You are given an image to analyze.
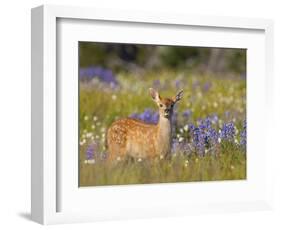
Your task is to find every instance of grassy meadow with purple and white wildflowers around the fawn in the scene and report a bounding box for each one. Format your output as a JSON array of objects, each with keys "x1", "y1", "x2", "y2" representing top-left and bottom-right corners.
[{"x1": 79, "y1": 67, "x2": 246, "y2": 186}]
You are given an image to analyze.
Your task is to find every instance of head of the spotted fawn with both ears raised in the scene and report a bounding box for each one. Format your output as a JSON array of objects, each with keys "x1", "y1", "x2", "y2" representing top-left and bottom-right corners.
[{"x1": 149, "y1": 88, "x2": 183, "y2": 119}]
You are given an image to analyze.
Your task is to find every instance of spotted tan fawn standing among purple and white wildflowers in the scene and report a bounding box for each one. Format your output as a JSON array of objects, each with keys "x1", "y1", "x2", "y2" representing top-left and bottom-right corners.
[{"x1": 106, "y1": 88, "x2": 183, "y2": 160}]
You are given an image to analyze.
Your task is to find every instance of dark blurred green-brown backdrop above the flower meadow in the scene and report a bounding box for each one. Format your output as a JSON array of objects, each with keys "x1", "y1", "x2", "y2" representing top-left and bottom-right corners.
[{"x1": 79, "y1": 42, "x2": 246, "y2": 76}]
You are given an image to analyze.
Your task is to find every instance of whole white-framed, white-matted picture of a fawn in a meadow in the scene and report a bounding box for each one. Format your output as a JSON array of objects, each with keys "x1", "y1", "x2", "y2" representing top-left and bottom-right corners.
[{"x1": 31, "y1": 6, "x2": 273, "y2": 224}]
